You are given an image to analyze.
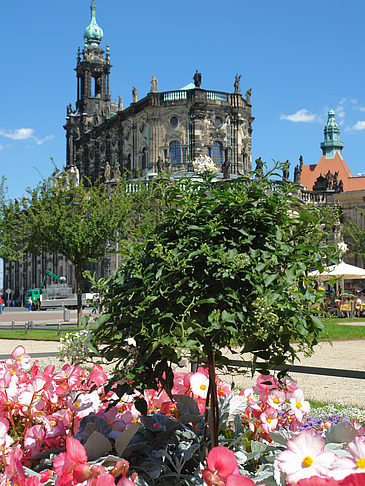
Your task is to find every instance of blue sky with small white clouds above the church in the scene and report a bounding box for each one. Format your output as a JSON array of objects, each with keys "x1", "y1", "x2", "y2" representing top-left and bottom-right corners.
[{"x1": 0, "y1": 0, "x2": 365, "y2": 197}]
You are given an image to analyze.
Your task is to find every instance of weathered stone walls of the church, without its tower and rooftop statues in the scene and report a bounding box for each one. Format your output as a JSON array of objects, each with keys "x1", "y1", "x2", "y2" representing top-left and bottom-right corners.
[{"x1": 65, "y1": 87, "x2": 253, "y2": 181}]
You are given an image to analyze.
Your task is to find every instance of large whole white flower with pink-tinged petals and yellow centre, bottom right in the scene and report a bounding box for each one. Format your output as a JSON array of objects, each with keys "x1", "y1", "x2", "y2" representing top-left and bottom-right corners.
[{"x1": 277, "y1": 430, "x2": 337, "y2": 484}]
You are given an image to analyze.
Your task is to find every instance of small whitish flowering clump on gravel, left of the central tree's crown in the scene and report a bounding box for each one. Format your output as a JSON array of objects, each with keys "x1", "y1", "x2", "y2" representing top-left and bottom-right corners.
[{"x1": 57, "y1": 329, "x2": 92, "y2": 363}]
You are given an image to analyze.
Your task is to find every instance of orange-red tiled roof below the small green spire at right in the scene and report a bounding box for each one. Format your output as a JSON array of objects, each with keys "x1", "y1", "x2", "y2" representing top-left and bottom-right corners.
[{"x1": 300, "y1": 153, "x2": 365, "y2": 192}]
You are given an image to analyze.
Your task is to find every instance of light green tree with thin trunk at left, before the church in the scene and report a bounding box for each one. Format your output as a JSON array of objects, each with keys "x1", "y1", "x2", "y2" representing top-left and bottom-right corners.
[{"x1": 0, "y1": 172, "x2": 162, "y2": 325}]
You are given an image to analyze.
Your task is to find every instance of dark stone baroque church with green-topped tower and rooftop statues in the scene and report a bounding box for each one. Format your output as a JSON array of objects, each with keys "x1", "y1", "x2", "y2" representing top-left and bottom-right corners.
[{"x1": 64, "y1": 0, "x2": 254, "y2": 181}]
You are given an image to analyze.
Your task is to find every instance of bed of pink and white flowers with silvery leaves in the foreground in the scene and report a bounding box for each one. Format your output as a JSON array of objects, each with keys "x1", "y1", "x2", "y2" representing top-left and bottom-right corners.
[{"x1": 0, "y1": 346, "x2": 365, "y2": 486}]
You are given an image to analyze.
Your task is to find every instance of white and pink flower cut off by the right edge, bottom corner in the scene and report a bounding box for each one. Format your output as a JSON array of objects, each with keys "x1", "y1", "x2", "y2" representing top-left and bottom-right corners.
[{"x1": 329, "y1": 436, "x2": 365, "y2": 480}]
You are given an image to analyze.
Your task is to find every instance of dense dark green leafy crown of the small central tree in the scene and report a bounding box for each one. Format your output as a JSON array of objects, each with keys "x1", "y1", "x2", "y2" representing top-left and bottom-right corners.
[{"x1": 91, "y1": 173, "x2": 336, "y2": 400}]
